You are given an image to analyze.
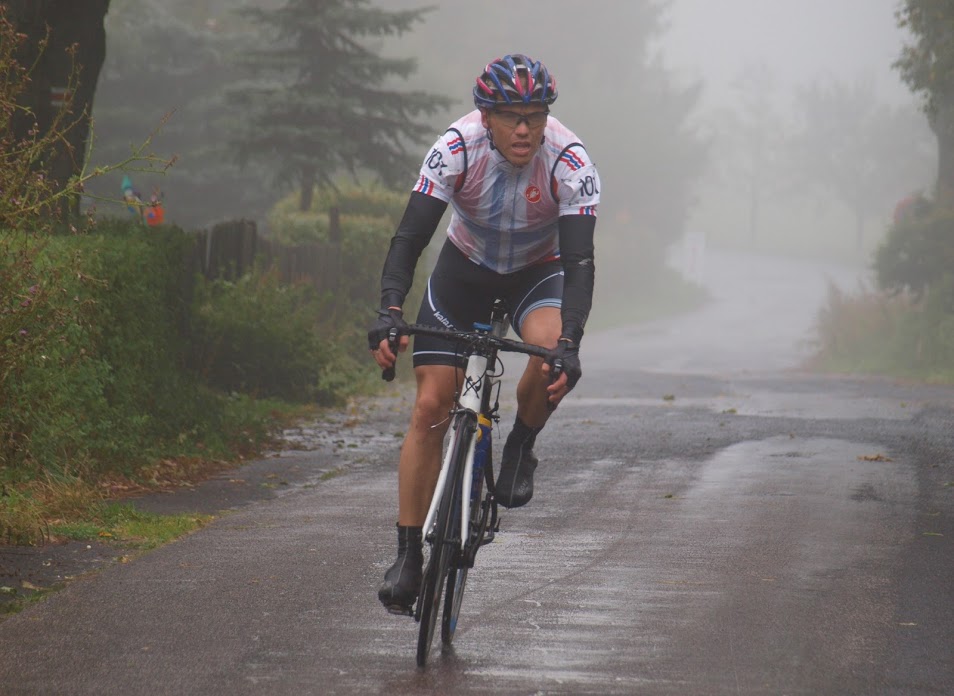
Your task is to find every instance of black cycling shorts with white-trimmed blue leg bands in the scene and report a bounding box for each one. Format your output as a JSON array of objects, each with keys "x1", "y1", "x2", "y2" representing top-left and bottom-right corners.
[{"x1": 414, "y1": 240, "x2": 563, "y2": 367}]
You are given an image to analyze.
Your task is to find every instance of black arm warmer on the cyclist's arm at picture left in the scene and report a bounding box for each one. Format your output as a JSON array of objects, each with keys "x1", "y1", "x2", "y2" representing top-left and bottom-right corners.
[{"x1": 381, "y1": 191, "x2": 447, "y2": 309}]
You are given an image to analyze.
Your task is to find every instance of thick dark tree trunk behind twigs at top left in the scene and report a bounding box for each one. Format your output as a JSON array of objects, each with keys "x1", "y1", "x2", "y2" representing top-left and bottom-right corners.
[{"x1": 7, "y1": 0, "x2": 110, "y2": 214}]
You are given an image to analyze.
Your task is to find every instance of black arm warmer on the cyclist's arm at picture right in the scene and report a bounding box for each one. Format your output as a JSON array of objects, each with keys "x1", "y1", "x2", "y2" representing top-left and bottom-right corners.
[{"x1": 559, "y1": 215, "x2": 596, "y2": 345}]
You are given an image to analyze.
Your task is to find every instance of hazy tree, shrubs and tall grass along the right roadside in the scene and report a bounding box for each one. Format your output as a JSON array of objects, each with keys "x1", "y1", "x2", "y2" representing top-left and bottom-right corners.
[{"x1": 814, "y1": 0, "x2": 954, "y2": 384}]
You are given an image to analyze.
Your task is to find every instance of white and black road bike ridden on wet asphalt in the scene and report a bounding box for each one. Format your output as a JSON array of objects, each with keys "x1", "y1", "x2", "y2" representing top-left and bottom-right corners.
[{"x1": 382, "y1": 300, "x2": 563, "y2": 667}]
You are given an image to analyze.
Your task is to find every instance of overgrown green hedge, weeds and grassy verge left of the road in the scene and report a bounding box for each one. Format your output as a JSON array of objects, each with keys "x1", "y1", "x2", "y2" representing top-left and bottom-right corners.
[{"x1": 0, "y1": 6, "x2": 376, "y2": 548}]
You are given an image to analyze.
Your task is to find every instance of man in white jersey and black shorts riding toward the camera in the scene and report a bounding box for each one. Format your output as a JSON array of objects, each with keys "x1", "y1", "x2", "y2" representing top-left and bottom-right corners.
[{"x1": 368, "y1": 54, "x2": 600, "y2": 613}]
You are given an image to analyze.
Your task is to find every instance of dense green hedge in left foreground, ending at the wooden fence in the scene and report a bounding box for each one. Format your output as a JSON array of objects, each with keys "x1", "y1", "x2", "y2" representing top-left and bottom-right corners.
[{"x1": 0, "y1": 223, "x2": 274, "y2": 479}]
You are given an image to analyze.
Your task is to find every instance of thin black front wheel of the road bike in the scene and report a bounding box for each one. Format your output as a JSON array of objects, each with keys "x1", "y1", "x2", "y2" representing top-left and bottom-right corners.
[{"x1": 417, "y1": 414, "x2": 473, "y2": 667}]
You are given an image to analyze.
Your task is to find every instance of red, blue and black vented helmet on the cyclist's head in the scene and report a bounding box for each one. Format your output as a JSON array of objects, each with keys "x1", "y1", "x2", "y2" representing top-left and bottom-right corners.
[{"x1": 474, "y1": 53, "x2": 557, "y2": 109}]
